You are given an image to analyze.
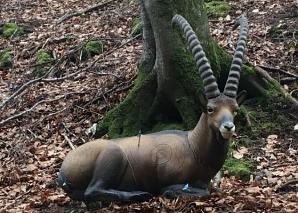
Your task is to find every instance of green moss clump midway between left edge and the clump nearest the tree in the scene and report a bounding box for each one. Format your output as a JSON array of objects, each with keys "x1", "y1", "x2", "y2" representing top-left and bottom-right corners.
[{"x1": 33, "y1": 49, "x2": 54, "y2": 77}]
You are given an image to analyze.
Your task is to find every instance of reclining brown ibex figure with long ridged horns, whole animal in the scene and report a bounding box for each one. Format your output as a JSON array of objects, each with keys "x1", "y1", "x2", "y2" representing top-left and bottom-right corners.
[{"x1": 58, "y1": 15, "x2": 248, "y2": 207}]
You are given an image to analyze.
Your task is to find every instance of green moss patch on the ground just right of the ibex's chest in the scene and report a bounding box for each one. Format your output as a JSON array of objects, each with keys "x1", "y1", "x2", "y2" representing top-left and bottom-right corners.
[{"x1": 223, "y1": 157, "x2": 253, "y2": 180}]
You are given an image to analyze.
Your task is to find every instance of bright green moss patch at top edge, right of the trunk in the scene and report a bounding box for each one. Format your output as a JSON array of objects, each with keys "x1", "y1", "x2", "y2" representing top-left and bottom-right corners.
[{"x1": 205, "y1": 1, "x2": 231, "y2": 17}]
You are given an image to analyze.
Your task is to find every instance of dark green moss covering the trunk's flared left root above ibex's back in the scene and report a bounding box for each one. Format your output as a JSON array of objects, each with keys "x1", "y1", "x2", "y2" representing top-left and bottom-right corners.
[{"x1": 96, "y1": 71, "x2": 156, "y2": 138}]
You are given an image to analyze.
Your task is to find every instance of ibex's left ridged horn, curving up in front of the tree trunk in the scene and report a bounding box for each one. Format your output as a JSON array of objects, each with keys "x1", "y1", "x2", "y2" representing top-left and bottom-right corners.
[{"x1": 172, "y1": 14, "x2": 220, "y2": 99}]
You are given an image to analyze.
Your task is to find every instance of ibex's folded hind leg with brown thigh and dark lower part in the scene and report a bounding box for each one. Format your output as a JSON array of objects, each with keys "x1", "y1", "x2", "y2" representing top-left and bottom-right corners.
[{"x1": 84, "y1": 144, "x2": 152, "y2": 201}]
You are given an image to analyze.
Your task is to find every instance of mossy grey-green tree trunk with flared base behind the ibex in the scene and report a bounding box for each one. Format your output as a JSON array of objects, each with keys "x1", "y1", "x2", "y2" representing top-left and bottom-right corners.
[{"x1": 97, "y1": 0, "x2": 265, "y2": 137}]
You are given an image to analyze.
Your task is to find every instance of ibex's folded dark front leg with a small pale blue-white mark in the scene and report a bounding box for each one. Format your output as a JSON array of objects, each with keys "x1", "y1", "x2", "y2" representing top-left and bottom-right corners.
[{"x1": 161, "y1": 184, "x2": 210, "y2": 198}]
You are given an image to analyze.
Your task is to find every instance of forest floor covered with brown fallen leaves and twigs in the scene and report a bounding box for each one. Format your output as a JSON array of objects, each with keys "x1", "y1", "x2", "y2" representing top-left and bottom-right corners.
[{"x1": 0, "y1": 0, "x2": 298, "y2": 212}]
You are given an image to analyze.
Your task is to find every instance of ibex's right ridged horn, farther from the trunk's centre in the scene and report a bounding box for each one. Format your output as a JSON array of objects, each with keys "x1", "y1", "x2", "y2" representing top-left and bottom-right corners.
[{"x1": 223, "y1": 15, "x2": 248, "y2": 98}]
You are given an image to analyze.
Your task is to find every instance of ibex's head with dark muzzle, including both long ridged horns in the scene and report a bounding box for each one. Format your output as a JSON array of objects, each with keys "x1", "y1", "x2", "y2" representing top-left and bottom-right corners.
[{"x1": 172, "y1": 15, "x2": 248, "y2": 140}]
